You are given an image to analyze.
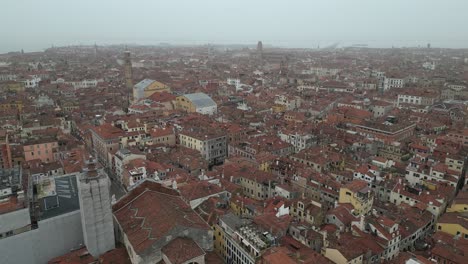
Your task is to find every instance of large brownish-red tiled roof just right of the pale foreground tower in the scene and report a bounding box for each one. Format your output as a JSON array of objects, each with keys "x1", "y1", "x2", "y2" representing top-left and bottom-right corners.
[{"x1": 112, "y1": 181, "x2": 210, "y2": 253}]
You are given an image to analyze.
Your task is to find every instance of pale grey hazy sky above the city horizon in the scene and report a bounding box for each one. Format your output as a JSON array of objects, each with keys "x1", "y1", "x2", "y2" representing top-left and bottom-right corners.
[{"x1": 0, "y1": 0, "x2": 468, "y2": 52}]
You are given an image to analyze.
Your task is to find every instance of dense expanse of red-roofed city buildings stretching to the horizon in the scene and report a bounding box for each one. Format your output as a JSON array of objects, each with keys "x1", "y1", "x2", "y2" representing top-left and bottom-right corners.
[{"x1": 0, "y1": 44, "x2": 468, "y2": 264}]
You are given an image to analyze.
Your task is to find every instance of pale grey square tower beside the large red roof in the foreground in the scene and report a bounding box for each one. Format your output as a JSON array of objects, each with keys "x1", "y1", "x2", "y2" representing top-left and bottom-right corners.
[{"x1": 78, "y1": 159, "x2": 115, "y2": 257}]
